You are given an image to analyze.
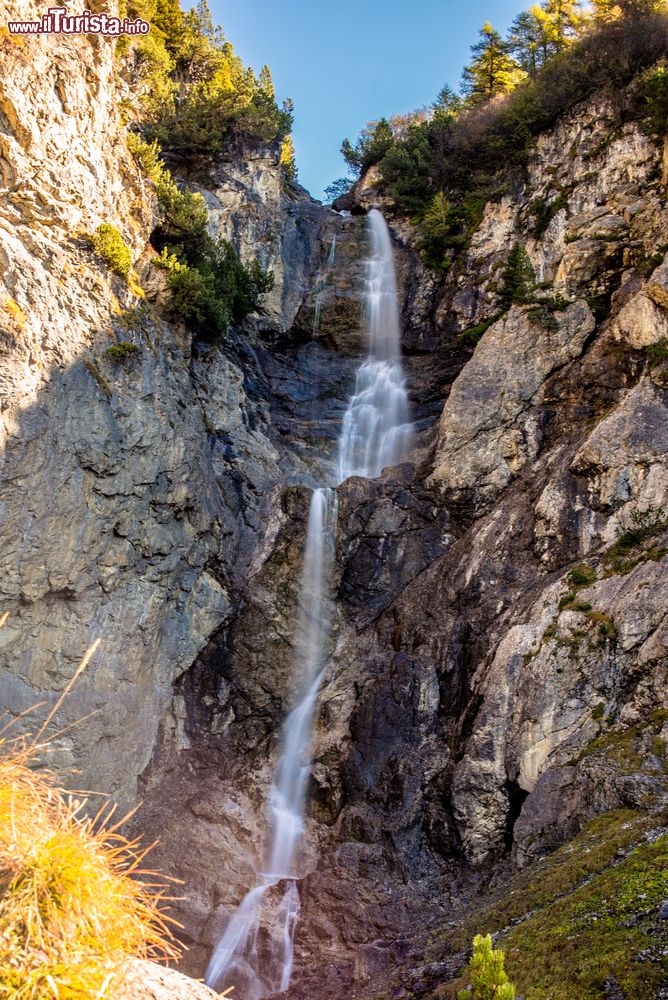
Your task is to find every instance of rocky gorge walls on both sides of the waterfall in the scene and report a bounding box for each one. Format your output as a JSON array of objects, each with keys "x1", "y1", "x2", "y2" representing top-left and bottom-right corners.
[{"x1": 0, "y1": 15, "x2": 668, "y2": 1000}]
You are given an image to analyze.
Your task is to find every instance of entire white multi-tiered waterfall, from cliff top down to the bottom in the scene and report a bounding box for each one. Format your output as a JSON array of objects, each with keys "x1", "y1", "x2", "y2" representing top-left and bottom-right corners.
[{"x1": 206, "y1": 210, "x2": 411, "y2": 1000}]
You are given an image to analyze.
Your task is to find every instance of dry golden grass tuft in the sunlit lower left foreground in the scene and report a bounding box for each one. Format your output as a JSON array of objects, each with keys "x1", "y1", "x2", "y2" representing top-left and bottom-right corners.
[{"x1": 0, "y1": 632, "x2": 183, "y2": 1000}]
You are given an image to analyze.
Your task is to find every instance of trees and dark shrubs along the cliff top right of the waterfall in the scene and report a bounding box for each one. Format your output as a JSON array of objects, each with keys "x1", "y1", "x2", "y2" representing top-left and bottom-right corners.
[{"x1": 342, "y1": 0, "x2": 668, "y2": 268}]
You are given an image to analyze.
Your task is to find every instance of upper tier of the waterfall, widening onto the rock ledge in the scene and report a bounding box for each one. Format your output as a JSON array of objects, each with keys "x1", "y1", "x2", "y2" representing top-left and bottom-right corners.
[{"x1": 339, "y1": 209, "x2": 411, "y2": 482}]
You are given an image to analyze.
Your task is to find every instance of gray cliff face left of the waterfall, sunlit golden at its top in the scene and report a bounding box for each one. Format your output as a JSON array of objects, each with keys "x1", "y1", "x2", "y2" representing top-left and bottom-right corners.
[{"x1": 0, "y1": 15, "x2": 359, "y2": 807}]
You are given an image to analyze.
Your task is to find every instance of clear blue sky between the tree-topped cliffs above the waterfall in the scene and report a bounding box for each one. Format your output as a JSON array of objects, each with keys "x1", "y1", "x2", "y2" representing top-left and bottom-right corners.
[{"x1": 206, "y1": 0, "x2": 531, "y2": 197}]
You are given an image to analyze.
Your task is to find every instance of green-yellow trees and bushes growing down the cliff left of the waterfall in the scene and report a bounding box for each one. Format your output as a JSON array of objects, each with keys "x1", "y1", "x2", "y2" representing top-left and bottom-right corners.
[{"x1": 115, "y1": 0, "x2": 280, "y2": 343}]
